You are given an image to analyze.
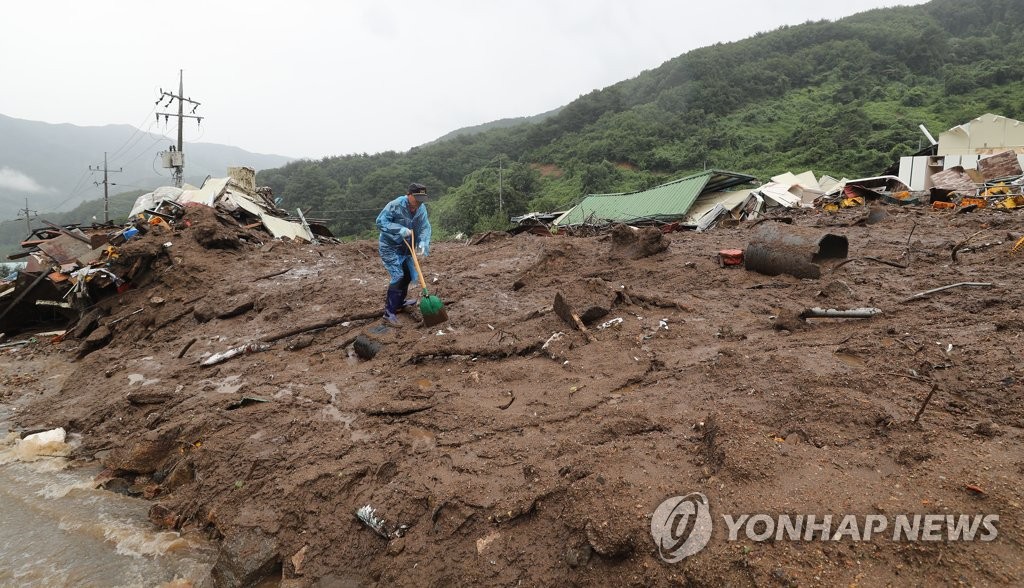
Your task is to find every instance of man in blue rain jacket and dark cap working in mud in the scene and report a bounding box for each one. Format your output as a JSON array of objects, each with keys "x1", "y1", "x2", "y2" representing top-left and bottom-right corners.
[{"x1": 377, "y1": 182, "x2": 430, "y2": 325}]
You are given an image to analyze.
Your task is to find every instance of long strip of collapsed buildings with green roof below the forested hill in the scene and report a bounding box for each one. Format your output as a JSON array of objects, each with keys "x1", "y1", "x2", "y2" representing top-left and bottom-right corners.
[{"x1": 511, "y1": 114, "x2": 1024, "y2": 235}]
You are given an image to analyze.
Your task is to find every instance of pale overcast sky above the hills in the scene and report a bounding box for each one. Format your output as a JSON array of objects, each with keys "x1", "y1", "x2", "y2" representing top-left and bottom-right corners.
[{"x1": 0, "y1": 0, "x2": 923, "y2": 158}]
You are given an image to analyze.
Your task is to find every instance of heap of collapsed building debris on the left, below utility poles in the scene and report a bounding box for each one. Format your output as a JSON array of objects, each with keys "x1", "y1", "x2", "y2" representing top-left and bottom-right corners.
[{"x1": 0, "y1": 167, "x2": 335, "y2": 335}]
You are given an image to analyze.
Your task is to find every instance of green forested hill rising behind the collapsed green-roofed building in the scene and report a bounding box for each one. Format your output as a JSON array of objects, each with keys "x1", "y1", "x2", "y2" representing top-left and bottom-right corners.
[{"x1": 253, "y1": 0, "x2": 1024, "y2": 239}]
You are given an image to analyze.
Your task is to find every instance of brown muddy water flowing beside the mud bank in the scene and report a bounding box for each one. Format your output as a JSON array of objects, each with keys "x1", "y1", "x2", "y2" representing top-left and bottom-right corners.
[{"x1": 0, "y1": 407, "x2": 216, "y2": 587}]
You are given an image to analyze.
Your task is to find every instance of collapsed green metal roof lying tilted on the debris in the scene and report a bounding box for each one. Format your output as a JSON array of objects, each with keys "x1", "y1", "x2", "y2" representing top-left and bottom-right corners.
[{"x1": 555, "y1": 170, "x2": 756, "y2": 226}]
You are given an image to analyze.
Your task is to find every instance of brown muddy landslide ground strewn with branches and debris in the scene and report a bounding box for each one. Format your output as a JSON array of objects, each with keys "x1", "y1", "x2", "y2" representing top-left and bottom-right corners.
[{"x1": 2, "y1": 207, "x2": 1024, "y2": 586}]
